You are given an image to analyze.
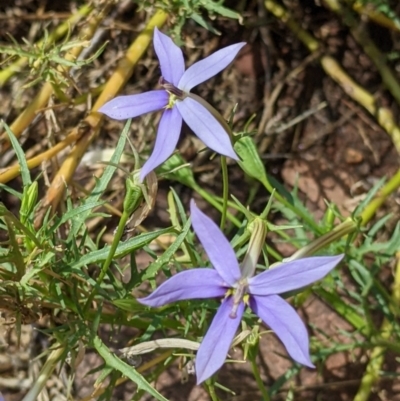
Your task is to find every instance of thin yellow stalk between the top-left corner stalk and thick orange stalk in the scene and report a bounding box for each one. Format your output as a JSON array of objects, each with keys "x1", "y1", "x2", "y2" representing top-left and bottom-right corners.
[{"x1": 0, "y1": 1, "x2": 113, "y2": 147}]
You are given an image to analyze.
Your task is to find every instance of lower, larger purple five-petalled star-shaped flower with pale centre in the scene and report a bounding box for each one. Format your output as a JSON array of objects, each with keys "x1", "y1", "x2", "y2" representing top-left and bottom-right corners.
[{"x1": 138, "y1": 201, "x2": 343, "y2": 384}]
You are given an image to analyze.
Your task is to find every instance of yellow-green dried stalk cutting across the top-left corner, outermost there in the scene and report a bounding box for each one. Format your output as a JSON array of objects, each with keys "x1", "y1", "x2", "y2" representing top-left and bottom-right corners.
[{"x1": 0, "y1": 4, "x2": 93, "y2": 88}]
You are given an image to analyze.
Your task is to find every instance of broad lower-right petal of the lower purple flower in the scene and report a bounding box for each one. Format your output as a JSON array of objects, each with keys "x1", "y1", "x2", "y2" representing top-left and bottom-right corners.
[{"x1": 250, "y1": 295, "x2": 315, "y2": 368}]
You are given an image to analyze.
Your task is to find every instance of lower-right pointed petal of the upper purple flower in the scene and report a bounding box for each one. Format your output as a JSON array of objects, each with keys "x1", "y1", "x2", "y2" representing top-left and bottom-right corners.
[{"x1": 176, "y1": 97, "x2": 238, "y2": 160}]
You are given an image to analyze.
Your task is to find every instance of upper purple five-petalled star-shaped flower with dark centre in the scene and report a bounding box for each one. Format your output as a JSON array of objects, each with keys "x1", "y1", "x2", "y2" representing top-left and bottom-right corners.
[{"x1": 99, "y1": 28, "x2": 245, "y2": 181}]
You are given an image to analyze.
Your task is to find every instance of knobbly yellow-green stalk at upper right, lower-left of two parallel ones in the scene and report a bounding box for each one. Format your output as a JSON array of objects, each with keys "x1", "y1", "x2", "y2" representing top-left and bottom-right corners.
[{"x1": 264, "y1": 0, "x2": 400, "y2": 154}]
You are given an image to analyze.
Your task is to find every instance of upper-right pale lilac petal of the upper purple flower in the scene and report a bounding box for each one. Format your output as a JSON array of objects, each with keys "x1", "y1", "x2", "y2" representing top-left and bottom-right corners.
[{"x1": 178, "y1": 42, "x2": 246, "y2": 92}]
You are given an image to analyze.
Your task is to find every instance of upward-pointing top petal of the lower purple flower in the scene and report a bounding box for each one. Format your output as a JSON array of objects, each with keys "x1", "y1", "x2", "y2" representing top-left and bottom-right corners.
[{"x1": 190, "y1": 199, "x2": 240, "y2": 286}]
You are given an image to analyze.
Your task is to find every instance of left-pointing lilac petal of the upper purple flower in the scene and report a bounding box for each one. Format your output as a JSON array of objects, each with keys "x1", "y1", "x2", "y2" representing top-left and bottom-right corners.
[{"x1": 98, "y1": 89, "x2": 169, "y2": 120}]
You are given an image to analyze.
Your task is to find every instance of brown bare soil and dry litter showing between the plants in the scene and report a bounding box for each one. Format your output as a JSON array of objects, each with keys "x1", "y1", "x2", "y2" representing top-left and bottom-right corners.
[{"x1": 0, "y1": 0, "x2": 400, "y2": 401}]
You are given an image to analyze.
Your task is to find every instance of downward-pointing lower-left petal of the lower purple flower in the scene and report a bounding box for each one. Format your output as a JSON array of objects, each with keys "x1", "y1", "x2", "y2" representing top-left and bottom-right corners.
[{"x1": 196, "y1": 297, "x2": 244, "y2": 384}]
